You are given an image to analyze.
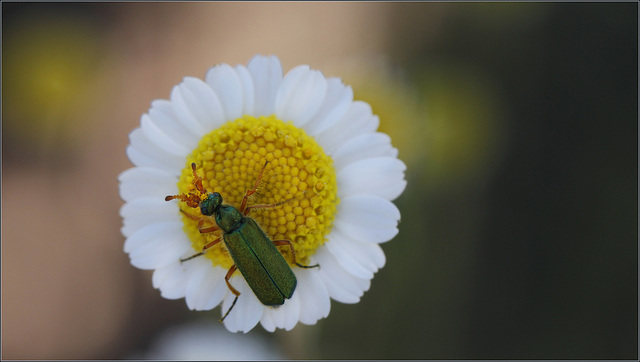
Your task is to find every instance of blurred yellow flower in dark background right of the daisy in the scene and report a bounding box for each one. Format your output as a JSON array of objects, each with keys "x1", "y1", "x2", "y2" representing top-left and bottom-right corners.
[{"x1": 419, "y1": 64, "x2": 505, "y2": 184}]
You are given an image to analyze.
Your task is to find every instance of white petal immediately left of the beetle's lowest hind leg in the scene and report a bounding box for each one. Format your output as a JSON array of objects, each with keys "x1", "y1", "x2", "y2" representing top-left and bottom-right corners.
[{"x1": 184, "y1": 257, "x2": 228, "y2": 310}]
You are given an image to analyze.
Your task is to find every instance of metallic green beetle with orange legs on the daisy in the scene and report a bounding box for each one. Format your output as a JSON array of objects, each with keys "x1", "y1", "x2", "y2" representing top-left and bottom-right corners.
[{"x1": 165, "y1": 161, "x2": 319, "y2": 322}]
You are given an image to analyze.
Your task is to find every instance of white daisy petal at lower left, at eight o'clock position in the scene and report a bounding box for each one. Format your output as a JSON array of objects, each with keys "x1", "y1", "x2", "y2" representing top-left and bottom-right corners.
[{"x1": 124, "y1": 221, "x2": 191, "y2": 269}]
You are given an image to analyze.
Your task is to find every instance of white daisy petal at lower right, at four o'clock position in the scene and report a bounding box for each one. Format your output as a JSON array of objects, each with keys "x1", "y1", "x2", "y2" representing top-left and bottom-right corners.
[{"x1": 325, "y1": 229, "x2": 384, "y2": 279}]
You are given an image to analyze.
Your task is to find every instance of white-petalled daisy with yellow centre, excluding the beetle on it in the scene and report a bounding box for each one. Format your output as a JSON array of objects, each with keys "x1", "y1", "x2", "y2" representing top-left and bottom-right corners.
[{"x1": 119, "y1": 56, "x2": 406, "y2": 333}]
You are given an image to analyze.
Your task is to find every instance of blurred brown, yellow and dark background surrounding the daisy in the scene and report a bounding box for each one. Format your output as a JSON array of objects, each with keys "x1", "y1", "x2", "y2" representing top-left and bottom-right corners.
[{"x1": 2, "y1": 2, "x2": 638, "y2": 359}]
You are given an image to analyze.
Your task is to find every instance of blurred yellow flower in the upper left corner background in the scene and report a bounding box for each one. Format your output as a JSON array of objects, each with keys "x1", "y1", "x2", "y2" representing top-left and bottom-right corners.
[{"x1": 2, "y1": 13, "x2": 101, "y2": 155}]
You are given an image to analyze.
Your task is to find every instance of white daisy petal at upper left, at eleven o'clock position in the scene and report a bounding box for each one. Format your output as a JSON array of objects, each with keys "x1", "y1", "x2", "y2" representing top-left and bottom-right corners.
[{"x1": 171, "y1": 77, "x2": 225, "y2": 136}]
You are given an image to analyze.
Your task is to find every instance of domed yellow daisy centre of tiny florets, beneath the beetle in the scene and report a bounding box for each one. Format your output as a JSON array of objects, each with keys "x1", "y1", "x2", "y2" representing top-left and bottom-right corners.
[{"x1": 172, "y1": 116, "x2": 339, "y2": 268}]
